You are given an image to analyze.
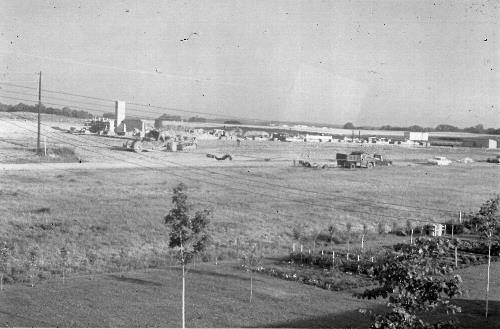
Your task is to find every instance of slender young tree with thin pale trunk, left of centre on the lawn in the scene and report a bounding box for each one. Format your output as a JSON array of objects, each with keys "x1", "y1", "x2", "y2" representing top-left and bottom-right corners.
[{"x1": 164, "y1": 183, "x2": 211, "y2": 328}]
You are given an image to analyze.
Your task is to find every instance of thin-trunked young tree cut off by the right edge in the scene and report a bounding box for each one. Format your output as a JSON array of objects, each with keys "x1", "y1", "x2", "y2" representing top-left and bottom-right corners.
[{"x1": 472, "y1": 196, "x2": 500, "y2": 317}]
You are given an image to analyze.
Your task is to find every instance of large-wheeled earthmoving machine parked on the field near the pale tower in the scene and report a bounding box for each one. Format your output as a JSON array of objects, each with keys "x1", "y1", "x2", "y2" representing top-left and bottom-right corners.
[{"x1": 123, "y1": 129, "x2": 198, "y2": 153}]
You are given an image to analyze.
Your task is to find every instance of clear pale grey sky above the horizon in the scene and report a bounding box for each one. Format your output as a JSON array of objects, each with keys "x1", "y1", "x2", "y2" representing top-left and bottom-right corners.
[{"x1": 0, "y1": 0, "x2": 500, "y2": 128}]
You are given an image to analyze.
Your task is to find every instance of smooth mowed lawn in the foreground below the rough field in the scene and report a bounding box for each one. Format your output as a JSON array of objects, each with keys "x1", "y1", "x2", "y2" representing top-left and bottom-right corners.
[{"x1": 0, "y1": 263, "x2": 500, "y2": 328}]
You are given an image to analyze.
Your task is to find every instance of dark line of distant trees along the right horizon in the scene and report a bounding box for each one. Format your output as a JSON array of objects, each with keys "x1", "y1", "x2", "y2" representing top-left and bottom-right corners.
[{"x1": 343, "y1": 122, "x2": 500, "y2": 135}]
